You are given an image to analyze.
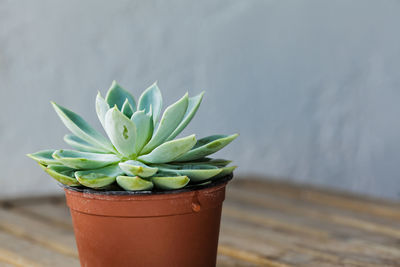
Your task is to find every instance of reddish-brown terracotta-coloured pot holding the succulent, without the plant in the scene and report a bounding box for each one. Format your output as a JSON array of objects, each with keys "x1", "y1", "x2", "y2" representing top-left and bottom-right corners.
[{"x1": 64, "y1": 176, "x2": 232, "y2": 267}]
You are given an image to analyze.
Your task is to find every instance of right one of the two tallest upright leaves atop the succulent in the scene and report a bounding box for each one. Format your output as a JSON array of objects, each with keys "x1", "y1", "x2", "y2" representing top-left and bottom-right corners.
[{"x1": 138, "y1": 82, "x2": 162, "y2": 125}]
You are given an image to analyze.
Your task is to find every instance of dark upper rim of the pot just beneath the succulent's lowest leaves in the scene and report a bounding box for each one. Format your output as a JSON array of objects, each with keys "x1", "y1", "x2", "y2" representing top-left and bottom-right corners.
[{"x1": 58, "y1": 173, "x2": 233, "y2": 196}]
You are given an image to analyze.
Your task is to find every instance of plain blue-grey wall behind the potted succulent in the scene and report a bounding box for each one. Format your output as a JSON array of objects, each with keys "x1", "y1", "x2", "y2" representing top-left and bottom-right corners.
[{"x1": 0, "y1": 0, "x2": 400, "y2": 198}]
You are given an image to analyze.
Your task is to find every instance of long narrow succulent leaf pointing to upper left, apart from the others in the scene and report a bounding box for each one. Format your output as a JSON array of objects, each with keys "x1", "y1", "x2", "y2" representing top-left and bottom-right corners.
[{"x1": 51, "y1": 102, "x2": 114, "y2": 152}]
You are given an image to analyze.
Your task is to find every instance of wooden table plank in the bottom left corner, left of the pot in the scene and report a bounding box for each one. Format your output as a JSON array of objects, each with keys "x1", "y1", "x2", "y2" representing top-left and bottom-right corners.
[{"x1": 0, "y1": 231, "x2": 79, "y2": 267}]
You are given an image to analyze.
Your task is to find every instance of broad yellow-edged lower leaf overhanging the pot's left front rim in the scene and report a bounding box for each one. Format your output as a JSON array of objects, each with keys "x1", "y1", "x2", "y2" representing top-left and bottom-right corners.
[{"x1": 75, "y1": 165, "x2": 123, "y2": 188}]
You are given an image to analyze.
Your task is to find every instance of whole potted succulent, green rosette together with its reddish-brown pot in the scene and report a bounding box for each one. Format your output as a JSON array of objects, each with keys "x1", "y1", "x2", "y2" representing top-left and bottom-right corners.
[{"x1": 28, "y1": 81, "x2": 238, "y2": 267}]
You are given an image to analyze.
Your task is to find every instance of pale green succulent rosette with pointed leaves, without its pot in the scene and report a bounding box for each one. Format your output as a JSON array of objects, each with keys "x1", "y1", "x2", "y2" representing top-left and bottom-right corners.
[{"x1": 28, "y1": 81, "x2": 238, "y2": 191}]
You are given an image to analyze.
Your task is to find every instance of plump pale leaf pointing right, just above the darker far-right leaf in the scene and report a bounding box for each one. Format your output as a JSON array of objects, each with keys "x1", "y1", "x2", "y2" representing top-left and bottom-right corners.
[{"x1": 138, "y1": 134, "x2": 196, "y2": 163}]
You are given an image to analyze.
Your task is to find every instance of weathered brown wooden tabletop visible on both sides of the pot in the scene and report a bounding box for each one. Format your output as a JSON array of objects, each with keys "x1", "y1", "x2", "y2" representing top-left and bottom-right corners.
[{"x1": 0, "y1": 179, "x2": 400, "y2": 267}]
